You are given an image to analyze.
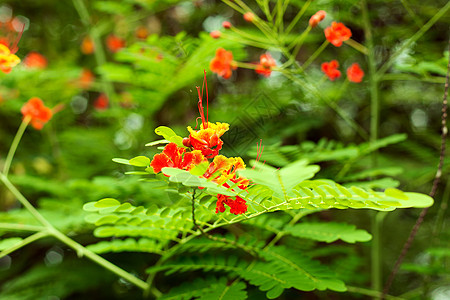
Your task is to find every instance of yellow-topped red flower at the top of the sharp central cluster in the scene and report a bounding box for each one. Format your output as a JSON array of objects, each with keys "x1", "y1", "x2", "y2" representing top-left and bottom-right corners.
[{"x1": 185, "y1": 122, "x2": 230, "y2": 158}]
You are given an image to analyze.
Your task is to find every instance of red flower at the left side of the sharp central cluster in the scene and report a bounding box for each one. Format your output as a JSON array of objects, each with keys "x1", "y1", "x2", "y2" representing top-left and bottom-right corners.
[{"x1": 150, "y1": 143, "x2": 205, "y2": 173}]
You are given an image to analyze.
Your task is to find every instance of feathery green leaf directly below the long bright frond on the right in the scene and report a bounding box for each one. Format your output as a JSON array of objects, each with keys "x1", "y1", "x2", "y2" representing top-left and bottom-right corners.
[{"x1": 284, "y1": 222, "x2": 372, "y2": 243}]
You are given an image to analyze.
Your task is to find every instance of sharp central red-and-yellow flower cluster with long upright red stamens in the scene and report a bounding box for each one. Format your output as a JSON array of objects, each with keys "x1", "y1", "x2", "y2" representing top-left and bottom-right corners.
[{"x1": 150, "y1": 75, "x2": 249, "y2": 215}]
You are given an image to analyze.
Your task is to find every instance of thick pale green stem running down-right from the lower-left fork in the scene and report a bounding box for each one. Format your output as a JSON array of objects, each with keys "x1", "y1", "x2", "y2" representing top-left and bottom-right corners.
[{"x1": 50, "y1": 228, "x2": 148, "y2": 290}]
